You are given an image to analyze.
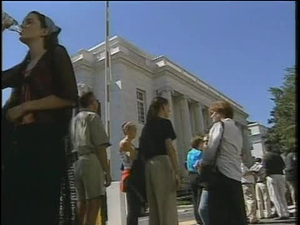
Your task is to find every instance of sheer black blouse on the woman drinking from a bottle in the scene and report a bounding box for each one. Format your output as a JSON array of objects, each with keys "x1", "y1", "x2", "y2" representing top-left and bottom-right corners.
[{"x1": 1, "y1": 45, "x2": 78, "y2": 131}]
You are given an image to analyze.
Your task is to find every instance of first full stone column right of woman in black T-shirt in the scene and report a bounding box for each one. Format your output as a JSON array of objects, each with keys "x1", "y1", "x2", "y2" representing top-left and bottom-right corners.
[{"x1": 179, "y1": 96, "x2": 192, "y2": 157}]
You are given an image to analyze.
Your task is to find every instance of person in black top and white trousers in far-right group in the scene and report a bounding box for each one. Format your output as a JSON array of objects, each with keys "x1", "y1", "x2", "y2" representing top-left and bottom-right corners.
[{"x1": 263, "y1": 149, "x2": 289, "y2": 220}]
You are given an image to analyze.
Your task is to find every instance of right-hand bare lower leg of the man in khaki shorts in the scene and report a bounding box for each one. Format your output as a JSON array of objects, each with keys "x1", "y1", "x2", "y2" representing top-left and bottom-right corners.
[{"x1": 83, "y1": 197, "x2": 100, "y2": 225}]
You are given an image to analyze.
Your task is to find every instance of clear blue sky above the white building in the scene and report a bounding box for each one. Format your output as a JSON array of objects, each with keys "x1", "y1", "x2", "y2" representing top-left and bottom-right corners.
[{"x1": 2, "y1": 1, "x2": 295, "y2": 125}]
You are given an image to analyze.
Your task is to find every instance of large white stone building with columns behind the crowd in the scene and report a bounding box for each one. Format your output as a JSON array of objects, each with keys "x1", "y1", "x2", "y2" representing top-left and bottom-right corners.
[{"x1": 72, "y1": 36, "x2": 250, "y2": 180}]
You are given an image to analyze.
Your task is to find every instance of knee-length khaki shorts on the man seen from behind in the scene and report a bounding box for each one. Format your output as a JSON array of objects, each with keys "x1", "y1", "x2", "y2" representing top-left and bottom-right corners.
[{"x1": 74, "y1": 153, "x2": 105, "y2": 201}]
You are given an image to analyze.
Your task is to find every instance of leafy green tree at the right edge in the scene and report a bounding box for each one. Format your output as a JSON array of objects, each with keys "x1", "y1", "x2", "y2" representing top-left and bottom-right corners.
[{"x1": 265, "y1": 67, "x2": 296, "y2": 152}]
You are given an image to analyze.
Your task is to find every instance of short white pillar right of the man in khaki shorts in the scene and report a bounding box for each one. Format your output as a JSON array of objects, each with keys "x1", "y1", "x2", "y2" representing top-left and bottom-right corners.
[{"x1": 106, "y1": 181, "x2": 127, "y2": 225}]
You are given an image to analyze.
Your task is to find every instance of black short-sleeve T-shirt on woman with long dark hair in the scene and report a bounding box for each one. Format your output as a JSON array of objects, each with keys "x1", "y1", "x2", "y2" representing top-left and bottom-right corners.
[{"x1": 140, "y1": 117, "x2": 176, "y2": 159}]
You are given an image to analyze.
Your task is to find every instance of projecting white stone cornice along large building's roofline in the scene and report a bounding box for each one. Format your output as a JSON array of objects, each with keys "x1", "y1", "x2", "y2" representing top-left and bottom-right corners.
[{"x1": 71, "y1": 36, "x2": 248, "y2": 117}]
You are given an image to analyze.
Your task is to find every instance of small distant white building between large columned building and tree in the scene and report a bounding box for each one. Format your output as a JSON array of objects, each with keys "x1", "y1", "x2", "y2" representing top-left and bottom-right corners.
[{"x1": 248, "y1": 122, "x2": 268, "y2": 158}]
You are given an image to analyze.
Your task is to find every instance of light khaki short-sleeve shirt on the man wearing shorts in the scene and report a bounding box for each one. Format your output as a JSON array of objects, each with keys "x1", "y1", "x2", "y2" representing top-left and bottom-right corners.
[{"x1": 70, "y1": 110, "x2": 110, "y2": 155}]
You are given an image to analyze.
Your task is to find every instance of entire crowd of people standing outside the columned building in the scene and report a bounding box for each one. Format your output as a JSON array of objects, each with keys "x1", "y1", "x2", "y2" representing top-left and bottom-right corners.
[{"x1": 2, "y1": 11, "x2": 297, "y2": 225}]
